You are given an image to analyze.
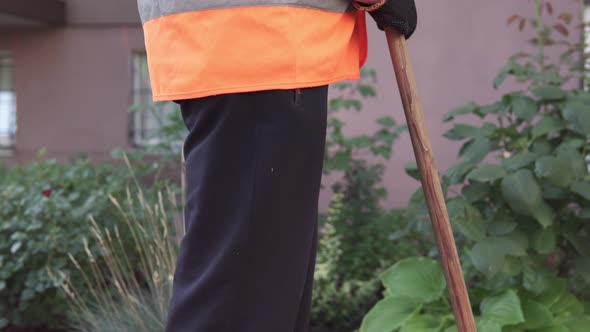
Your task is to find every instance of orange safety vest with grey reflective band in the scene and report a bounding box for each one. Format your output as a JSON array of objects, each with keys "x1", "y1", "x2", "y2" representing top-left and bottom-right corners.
[{"x1": 138, "y1": 0, "x2": 367, "y2": 101}]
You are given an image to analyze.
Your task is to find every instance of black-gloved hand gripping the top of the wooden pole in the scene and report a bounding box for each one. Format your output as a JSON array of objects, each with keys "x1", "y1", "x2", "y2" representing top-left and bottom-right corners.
[{"x1": 357, "y1": 0, "x2": 418, "y2": 38}]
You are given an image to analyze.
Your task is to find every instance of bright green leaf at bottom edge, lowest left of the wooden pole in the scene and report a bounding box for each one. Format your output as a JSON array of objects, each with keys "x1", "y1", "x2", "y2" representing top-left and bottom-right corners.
[{"x1": 361, "y1": 297, "x2": 421, "y2": 332}]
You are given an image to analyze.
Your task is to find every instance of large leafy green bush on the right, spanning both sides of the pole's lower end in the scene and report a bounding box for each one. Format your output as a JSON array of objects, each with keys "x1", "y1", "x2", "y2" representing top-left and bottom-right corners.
[{"x1": 361, "y1": 0, "x2": 590, "y2": 332}]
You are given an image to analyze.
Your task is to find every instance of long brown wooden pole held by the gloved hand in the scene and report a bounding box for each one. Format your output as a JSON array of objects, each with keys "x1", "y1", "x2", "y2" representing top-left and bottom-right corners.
[{"x1": 385, "y1": 28, "x2": 477, "y2": 332}]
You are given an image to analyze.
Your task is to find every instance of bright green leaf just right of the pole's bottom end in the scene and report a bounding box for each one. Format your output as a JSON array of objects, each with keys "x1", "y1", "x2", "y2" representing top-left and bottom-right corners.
[{"x1": 480, "y1": 290, "x2": 524, "y2": 326}]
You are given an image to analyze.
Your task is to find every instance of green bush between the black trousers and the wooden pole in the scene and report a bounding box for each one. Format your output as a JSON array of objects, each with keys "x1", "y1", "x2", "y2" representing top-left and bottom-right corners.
[{"x1": 312, "y1": 70, "x2": 430, "y2": 332}]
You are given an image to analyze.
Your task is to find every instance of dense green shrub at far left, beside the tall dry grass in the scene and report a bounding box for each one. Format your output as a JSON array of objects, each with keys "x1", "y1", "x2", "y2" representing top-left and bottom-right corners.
[{"x1": 0, "y1": 154, "x2": 176, "y2": 328}]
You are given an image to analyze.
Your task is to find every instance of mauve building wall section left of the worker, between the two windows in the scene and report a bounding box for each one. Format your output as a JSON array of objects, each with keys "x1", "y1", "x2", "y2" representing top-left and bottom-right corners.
[{"x1": 0, "y1": 0, "x2": 144, "y2": 162}]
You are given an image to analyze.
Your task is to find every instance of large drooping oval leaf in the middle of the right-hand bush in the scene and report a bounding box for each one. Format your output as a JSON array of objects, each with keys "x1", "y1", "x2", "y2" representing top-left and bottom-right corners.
[{"x1": 502, "y1": 169, "x2": 553, "y2": 227}]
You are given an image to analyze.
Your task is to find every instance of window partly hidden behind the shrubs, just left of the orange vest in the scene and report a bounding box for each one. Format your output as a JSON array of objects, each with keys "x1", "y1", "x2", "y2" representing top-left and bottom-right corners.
[{"x1": 129, "y1": 53, "x2": 178, "y2": 147}]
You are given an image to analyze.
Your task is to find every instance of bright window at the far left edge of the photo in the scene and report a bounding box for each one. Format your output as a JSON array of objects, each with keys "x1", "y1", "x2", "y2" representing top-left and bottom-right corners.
[{"x1": 0, "y1": 51, "x2": 16, "y2": 153}]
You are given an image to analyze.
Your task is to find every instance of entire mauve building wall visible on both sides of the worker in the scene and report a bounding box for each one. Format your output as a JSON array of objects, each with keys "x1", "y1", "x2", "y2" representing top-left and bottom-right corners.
[{"x1": 0, "y1": 0, "x2": 577, "y2": 206}]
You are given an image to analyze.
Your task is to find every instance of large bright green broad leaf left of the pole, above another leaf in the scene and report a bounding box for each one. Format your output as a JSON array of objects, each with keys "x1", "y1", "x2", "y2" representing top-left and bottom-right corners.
[{"x1": 380, "y1": 257, "x2": 445, "y2": 302}]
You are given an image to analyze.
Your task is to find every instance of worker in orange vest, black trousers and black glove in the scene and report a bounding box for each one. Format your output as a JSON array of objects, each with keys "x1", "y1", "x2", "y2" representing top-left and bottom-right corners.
[{"x1": 138, "y1": 0, "x2": 417, "y2": 332}]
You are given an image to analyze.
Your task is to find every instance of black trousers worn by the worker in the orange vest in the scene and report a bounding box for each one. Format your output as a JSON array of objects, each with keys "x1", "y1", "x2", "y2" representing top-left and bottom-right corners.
[{"x1": 166, "y1": 86, "x2": 327, "y2": 332}]
